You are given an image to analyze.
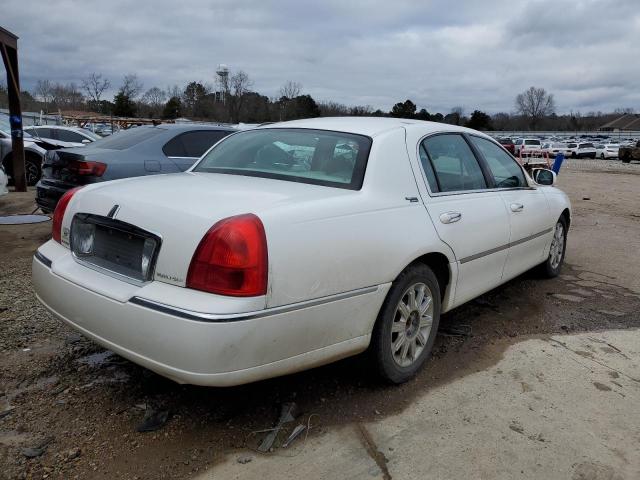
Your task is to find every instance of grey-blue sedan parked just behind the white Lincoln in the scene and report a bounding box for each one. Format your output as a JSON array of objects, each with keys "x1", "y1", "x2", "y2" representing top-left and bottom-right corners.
[{"x1": 36, "y1": 124, "x2": 236, "y2": 213}]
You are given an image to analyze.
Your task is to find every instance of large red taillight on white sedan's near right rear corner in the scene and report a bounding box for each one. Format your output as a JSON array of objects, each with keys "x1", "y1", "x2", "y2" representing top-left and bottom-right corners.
[{"x1": 186, "y1": 214, "x2": 268, "y2": 297}]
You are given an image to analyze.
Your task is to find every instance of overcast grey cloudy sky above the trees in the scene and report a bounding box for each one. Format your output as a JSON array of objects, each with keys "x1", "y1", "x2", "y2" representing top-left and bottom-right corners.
[{"x1": 0, "y1": 0, "x2": 640, "y2": 113}]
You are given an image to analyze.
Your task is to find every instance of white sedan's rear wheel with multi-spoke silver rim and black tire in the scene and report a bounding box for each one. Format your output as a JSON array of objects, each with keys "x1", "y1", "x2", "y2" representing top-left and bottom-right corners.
[{"x1": 370, "y1": 264, "x2": 441, "y2": 384}]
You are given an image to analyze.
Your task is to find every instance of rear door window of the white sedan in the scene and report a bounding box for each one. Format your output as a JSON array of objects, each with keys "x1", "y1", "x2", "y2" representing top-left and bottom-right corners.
[{"x1": 421, "y1": 134, "x2": 487, "y2": 192}]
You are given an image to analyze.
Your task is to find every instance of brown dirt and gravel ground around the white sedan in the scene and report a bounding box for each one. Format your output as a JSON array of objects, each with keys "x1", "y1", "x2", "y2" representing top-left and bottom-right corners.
[{"x1": 0, "y1": 161, "x2": 640, "y2": 479}]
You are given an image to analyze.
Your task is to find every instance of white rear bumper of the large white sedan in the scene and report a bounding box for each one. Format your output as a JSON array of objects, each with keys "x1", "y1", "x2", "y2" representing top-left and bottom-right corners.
[{"x1": 33, "y1": 242, "x2": 390, "y2": 386}]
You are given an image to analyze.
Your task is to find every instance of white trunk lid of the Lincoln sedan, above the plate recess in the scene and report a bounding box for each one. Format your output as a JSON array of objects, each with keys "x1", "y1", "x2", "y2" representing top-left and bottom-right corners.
[{"x1": 65, "y1": 172, "x2": 355, "y2": 286}]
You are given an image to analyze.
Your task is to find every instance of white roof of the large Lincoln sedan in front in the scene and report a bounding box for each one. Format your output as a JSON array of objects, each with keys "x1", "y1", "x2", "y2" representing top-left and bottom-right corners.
[{"x1": 258, "y1": 117, "x2": 475, "y2": 137}]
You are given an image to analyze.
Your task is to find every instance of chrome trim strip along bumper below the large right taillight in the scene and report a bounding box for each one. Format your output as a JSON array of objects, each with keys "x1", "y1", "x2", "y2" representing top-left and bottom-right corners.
[{"x1": 129, "y1": 286, "x2": 378, "y2": 322}]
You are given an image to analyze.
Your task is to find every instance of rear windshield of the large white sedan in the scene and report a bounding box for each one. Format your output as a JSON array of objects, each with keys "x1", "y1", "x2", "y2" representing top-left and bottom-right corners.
[{"x1": 193, "y1": 128, "x2": 371, "y2": 190}]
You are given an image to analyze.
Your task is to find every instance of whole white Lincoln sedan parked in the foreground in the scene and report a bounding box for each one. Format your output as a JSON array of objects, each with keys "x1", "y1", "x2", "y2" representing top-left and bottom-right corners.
[{"x1": 33, "y1": 117, "x2": 571, "y2": 386}]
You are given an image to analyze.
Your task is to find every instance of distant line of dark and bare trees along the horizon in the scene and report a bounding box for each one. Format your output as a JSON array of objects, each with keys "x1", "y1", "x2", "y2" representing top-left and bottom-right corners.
[{"x1": 0, "y1": 70, "x2": 633, "y2": 131}]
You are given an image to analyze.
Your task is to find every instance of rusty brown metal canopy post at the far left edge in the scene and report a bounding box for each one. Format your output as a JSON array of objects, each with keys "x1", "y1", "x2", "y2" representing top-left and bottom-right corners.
[{"x1": 0, "y1": 27, "x2": 27, "y2": 192}]
